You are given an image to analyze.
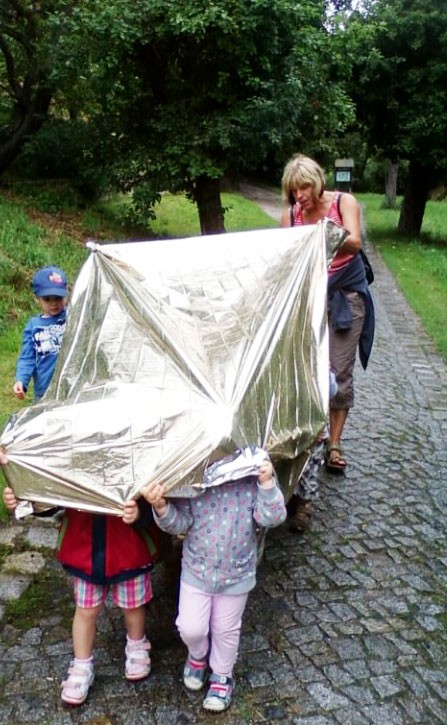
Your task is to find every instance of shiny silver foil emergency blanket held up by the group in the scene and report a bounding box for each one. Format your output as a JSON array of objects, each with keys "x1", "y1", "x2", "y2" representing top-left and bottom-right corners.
[{"x1": 0, "y1": 220, "x2": 346, "y2": 514}]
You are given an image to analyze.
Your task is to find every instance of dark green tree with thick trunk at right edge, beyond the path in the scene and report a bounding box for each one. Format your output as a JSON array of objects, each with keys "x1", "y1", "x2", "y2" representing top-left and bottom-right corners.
[{"x1": 350, "y1": 0, "x2": 447, "y2": 236}]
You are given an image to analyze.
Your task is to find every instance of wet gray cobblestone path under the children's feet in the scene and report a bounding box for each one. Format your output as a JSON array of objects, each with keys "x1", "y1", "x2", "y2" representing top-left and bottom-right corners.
[{"x1": 0, "y1": 194, "x2": 447, "y2": 725}]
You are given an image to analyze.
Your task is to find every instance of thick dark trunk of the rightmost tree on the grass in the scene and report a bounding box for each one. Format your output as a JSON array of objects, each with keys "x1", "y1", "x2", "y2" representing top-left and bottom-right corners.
[{"x1": 397, "y1": 161, "x2": 431, "y2": 237}]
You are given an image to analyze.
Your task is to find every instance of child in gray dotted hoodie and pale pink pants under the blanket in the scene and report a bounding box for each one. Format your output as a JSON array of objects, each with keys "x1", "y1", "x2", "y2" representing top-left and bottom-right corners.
[{"x1": 142, "y1": 448, "x2": 286, "y2": 712}]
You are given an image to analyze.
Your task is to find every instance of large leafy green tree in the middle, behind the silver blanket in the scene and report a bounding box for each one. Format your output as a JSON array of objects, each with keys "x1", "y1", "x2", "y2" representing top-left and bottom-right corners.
[{"x1": 63, "y1": 0, "x2": 352, "y2": 233}]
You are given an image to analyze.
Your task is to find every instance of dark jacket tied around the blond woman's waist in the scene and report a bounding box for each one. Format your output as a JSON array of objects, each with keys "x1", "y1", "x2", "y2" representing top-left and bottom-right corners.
[{"x1": 328, "y1": 254, "x2": 375, "y2": 370}]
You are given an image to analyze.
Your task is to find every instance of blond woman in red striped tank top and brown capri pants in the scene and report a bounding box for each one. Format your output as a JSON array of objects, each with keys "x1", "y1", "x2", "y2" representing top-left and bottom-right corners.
[{"x1": 281, "y1": 154, "x2": 374, "y2": 473}]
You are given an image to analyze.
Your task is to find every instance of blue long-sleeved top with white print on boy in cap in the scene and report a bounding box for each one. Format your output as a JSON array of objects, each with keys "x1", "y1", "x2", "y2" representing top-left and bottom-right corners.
[{"x1": 15, "y1": 310, "x2": 67, "y2": 398}]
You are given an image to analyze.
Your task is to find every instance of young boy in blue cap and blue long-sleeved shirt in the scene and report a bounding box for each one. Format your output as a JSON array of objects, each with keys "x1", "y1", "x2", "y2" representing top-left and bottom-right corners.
[{"x1": 12, "y1": 266, "x2": 68, "y2": 400}]
